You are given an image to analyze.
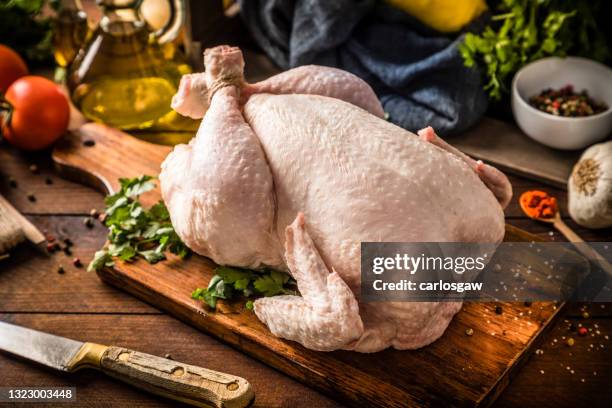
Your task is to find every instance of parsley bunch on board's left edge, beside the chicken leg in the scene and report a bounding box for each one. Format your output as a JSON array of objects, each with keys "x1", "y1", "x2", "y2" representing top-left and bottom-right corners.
[{"x1": 88, "y1": 176, "x2": 189, "y2": 270}]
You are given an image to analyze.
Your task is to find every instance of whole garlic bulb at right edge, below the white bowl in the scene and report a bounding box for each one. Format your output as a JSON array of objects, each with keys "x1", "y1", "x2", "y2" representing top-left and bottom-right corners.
[{"x1": 567, "y1": 141, "x2": 612, "y2": 228}]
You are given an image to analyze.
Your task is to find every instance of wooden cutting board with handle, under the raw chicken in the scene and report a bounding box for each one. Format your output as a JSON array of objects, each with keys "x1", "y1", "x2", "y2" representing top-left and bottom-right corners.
[{"x1": 53, "y1": 124, "x2": 560, "y2": 407}]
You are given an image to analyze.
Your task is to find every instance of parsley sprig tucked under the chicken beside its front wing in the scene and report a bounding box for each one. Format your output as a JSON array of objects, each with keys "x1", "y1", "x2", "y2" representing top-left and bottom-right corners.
[{"x1": 191, "y1": 266, "x2": 296, "y2": 310}]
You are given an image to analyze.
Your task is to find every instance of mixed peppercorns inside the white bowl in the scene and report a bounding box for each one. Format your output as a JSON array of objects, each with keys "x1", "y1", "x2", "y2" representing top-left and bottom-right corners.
[{"x1": 529, "y1": 85, "x2": 608, "y2": 117}]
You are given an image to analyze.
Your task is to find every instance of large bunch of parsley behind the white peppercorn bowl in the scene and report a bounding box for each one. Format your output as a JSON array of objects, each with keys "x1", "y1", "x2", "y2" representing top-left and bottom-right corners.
[{"x1": 459, "y1": 0, "x2": 610, "y2": 100}]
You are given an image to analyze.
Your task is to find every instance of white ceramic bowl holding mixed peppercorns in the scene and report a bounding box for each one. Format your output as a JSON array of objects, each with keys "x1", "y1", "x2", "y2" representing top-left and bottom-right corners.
[{"x1": 512, "y1": 57, "x2": 612, "y2": 150}]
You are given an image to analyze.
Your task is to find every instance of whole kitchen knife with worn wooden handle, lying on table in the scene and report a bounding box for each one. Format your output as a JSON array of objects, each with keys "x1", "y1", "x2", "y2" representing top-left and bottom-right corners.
[{"x1": 0, "y1": 321, "x2": 255, "y2": 408}]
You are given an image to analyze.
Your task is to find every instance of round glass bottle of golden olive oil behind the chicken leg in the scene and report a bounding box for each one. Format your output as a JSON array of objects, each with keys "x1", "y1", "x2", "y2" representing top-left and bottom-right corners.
[{"x1": 68, "y1": 0, "x2": 197, "y2": 132}]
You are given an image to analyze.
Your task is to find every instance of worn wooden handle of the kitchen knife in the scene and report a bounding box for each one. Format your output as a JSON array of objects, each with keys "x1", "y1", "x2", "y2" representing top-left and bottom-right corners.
[{"x1": 100, "y1": 347, "x2": 254, "y2": 408}]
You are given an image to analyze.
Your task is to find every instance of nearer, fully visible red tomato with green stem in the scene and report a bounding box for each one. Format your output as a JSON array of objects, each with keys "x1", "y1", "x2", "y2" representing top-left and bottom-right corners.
[{"x1": 3, "y1": 76, "x2": 70, "y2": 150}]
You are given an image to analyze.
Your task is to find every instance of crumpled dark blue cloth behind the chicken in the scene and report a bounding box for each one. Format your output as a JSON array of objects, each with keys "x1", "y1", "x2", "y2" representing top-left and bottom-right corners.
[{"x1": 241, "y1": 0, "x2": 487, "y2": 135}]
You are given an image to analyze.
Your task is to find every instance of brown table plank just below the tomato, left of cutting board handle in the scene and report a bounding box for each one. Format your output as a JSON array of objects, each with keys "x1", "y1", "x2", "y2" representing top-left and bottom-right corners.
[{"x1": 0, "y1": 145, "x2": 103, "y2": 214}]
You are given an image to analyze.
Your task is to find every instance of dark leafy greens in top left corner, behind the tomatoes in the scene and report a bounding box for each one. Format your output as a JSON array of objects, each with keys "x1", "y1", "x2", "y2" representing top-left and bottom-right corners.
[{"x1": 0, "y1": 0, "x2": 59, "y2": 63}]
